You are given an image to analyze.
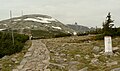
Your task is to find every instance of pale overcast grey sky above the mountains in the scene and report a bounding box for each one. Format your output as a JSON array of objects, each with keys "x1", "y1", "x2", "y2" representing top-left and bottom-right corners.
[{"x1": 0, "y1": 0, "x2": 120, "y2": 27}]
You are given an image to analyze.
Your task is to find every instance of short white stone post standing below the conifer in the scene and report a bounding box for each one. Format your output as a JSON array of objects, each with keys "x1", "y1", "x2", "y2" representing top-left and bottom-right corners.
[{"x1": 104, "y1": 36, "x2": 113, "y2": 55}]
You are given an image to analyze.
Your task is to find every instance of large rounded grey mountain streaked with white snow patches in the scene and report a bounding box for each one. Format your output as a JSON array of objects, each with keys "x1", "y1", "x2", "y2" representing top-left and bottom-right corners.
[{"x1": 0, "y1": 14, "x2": 73, "y2": 38}]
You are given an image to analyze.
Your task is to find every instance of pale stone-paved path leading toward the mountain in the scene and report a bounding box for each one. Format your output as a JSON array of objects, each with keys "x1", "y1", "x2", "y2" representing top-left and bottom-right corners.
[{"x1": 12, "y1": 40, "x2": 50, "y2": 71}]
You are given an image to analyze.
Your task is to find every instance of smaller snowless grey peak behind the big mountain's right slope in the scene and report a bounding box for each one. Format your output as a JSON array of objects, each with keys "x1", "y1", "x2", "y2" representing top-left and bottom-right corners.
[{"x1": 67, "y1": 24, "x2": 90, "y2": 33}]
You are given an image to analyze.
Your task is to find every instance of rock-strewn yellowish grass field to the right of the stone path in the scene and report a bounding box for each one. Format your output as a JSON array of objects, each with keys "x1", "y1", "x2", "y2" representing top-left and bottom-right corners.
[{"x1": 42, "y1": 36, "x2": 120, "y2": 71}]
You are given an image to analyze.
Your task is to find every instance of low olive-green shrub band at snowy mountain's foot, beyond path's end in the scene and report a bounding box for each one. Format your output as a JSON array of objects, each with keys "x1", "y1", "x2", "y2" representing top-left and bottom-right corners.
[{"x1": 31, "y1": 30, "x2": 71, "y2": 39}]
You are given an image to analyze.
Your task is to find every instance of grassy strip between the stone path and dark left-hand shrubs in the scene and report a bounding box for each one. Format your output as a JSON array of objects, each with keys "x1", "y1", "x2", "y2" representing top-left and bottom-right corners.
[{"x1": 0, "y1": 40, "x2": 31, "y2": 71}]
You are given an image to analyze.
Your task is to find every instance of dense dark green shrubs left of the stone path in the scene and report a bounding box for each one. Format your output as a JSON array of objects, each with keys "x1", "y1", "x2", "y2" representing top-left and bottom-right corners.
[{"x1": 0, "y1": 32, "x2": 29, "y2": 57}]
